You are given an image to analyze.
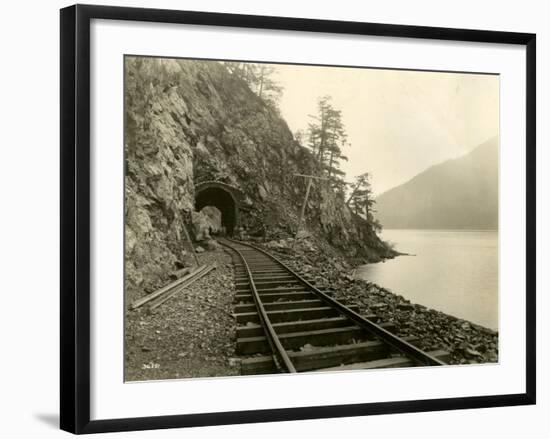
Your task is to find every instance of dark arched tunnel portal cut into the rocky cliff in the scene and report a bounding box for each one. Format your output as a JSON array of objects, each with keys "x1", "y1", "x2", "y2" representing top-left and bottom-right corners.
[{"x1": 195, "y1": 181, "x2": 243, "y2": 236}]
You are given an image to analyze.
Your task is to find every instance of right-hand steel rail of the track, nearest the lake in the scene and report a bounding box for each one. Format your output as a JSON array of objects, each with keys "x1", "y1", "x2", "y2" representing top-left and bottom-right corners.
[{"x1": 228, "y1": 239, "x2": 446, "y2": 366}]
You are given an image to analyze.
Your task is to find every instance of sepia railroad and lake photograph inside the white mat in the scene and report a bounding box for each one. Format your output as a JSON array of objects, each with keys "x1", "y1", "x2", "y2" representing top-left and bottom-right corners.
[{"x1": 124, "y1": 55, "x2": 499, "y2": 382}]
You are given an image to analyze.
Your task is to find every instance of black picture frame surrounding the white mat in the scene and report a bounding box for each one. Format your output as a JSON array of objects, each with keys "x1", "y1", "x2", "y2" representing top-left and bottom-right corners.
[{"x1": 60, "y1": 5, "x2": 536, "y2": 434}]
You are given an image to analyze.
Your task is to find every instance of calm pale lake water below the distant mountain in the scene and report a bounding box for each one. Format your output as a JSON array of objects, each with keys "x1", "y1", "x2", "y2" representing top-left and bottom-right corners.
[{"x1": 355, "y1": 229, "x2": 498, "y2": 329}]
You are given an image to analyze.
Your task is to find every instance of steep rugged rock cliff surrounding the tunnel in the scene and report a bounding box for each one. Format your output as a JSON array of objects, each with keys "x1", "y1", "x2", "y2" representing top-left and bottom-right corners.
[{"x1": 125, "y1": 57, "x2": 391, "y2": 300}]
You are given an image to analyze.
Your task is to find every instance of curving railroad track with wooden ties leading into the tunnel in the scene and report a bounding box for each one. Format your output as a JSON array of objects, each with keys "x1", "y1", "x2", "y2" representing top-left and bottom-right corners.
[{"x1": 219, "y1": 239, "x2": 448, "y2": 375}]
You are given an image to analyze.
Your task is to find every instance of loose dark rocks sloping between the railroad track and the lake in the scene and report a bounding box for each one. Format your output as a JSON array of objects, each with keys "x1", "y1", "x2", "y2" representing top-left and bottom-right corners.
[{"x1": 263, "y1": 240, "x2": 499, "y2": 364}]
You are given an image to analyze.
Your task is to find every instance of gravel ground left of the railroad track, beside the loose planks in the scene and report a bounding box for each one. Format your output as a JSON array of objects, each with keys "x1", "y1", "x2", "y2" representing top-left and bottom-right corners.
[{"x1": 125, "y1": 249, "x2": 240, "y2": 381}]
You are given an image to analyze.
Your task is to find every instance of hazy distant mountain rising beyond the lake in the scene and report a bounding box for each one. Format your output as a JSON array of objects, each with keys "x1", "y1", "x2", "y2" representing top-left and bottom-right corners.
[{"x1": 376, "y1": 137, "x2": 498, "y2": 229}]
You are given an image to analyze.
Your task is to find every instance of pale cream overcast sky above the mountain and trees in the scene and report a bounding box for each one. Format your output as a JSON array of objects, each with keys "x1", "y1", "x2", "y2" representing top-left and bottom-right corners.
[{"x1": 276, "y1": 65, "x2": 499, "y2": 195}]
